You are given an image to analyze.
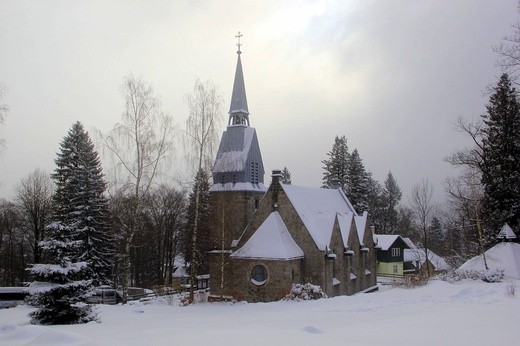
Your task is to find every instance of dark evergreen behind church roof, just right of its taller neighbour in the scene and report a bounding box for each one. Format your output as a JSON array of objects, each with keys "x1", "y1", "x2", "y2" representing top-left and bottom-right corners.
[{"x1": 345, "y1": 149, "x2": 373, "y2": 213}]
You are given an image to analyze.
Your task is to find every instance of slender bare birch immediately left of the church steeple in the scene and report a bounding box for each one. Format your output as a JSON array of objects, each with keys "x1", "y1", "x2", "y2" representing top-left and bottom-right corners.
[{"x1": 184, "y1": 80, "x2": 222, "y2": 302}]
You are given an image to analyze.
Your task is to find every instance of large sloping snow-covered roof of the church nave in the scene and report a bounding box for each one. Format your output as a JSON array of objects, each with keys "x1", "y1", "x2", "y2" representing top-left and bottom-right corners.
[{"x1": 281, "y1": 184, "x2": 358, "y2": 251}]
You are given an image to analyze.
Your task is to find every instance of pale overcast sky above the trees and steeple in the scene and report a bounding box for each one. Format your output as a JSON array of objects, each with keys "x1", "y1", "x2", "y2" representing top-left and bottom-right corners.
[{"x1": 0, "y1": 0, "x2": 518, "y2": 203}]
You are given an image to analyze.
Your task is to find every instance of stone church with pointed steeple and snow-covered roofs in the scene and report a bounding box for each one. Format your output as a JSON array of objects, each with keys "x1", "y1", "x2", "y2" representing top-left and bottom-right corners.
[{"x1": 208, "y1": 39, "x2": 376, "y2": 302}]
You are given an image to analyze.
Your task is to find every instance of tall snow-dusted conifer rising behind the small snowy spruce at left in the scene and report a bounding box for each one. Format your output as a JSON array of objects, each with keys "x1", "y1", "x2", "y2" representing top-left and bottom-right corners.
[{"x1": 52, "y1": 122, "x2": 113, "y2": 284}]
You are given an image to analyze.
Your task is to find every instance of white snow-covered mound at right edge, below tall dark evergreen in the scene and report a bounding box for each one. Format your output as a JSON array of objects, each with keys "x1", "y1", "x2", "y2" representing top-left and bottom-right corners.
[{"x1": 456, "y1": 242, "x2": 520, "y2": 279}]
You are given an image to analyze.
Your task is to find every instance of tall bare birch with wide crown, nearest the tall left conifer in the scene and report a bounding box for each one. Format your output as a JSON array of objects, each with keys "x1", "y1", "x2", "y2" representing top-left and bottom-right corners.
[{"x1": 101, "y1": 76, "x2": 174, "y2": 300}]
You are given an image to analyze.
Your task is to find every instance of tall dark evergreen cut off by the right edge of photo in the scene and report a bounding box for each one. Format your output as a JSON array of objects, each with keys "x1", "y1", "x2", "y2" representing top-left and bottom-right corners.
[{"x1": 481, "y1": 74, "x2": 520, "y2": 231}]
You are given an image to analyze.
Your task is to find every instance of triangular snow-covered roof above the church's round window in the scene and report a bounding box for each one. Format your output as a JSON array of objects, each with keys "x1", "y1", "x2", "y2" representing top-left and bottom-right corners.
[{"x1": 231, "y1": 211, "x2": 304, "y2": 260}]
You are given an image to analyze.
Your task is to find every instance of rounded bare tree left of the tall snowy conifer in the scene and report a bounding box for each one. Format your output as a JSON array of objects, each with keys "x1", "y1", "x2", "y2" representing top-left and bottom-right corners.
[{"x1": 16, "y1": 169, "x2": 54, "y2": 263}]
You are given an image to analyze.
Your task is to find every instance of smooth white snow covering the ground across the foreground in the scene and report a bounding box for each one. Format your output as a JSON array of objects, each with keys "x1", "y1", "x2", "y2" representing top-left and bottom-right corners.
[{"x1": 0, "y1": 280, "x2": 520, "y2": 346}]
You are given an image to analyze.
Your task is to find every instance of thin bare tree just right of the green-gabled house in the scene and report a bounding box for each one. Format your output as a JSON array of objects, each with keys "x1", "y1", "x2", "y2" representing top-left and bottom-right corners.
[{"x1": 410, "y1": 179, "x2": 436, "y2": 278}]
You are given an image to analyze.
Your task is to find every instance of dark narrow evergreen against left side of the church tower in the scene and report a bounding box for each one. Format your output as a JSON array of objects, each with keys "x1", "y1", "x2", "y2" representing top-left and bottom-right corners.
[{"x1": 181, "y1": 169, "x2": 211, "y2": 274}]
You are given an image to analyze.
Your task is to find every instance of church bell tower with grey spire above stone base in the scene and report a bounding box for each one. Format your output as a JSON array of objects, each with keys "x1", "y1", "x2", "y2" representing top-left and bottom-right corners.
[{"x1": 208, "y1": 32, "x2": 267, "y2": 295}]
